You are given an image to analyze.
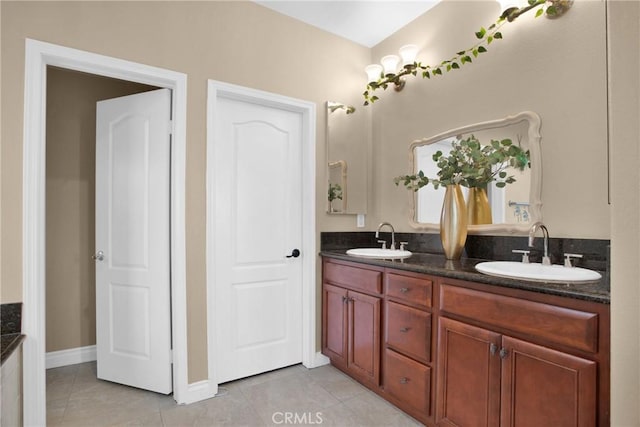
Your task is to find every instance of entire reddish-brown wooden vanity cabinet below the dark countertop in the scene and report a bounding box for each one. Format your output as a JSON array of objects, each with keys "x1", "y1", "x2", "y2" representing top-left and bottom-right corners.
[{"x1": 322, "y1": 258, "x2": 610, "y2": 427}]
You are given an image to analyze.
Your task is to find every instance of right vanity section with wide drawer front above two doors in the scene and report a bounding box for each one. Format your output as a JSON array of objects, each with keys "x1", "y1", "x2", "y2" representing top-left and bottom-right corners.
[{"x1": 436, "y1": 283, "x2": 609, "y2": 427}]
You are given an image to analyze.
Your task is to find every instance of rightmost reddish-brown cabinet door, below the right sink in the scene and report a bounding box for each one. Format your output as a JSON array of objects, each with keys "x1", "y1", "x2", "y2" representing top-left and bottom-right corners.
[{"x1": 501, "y1": 337, "x2": 596, "y2": 427}]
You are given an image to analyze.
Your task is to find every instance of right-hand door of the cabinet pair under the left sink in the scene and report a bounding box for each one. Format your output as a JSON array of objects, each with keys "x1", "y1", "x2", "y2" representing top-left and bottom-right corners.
[{"x1": 347, "y1": 291, "x2": 381, "y2": 386}]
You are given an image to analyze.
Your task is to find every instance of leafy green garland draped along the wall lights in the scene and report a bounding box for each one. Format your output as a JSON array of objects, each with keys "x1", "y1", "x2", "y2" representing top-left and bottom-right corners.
[{"x1": 362, "y1": 0, "x2": 573, "y2": 105}]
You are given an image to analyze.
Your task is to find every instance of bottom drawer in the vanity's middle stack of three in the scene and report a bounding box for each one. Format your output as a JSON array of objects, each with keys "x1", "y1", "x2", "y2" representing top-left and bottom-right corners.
[{"x1": 384, "y1": 349, "x2": 431, "y2": 415}]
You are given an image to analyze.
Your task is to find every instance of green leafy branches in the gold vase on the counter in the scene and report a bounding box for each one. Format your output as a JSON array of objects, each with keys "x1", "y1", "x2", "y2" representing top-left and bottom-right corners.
[{"x1": 394, "y1": 135, "x2": 530, "y2": 191}]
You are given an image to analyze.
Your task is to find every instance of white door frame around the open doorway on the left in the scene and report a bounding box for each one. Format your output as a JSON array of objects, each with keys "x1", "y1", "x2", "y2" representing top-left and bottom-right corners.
[{"x1": 22, "y1": 39, "x2": 191, "y2": 426}]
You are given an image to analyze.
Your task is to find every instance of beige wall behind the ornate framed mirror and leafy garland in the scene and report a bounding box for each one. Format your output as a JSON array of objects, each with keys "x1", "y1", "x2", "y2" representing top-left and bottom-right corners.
[{"x1": 371, "y1": 0, "x2": 610, "y2": 239}]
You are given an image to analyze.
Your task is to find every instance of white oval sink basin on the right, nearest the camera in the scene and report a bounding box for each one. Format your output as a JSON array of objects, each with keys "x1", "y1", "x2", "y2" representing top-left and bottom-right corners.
[{"x1": 476, "y1": 261, "x2": 602, "y2": 283}]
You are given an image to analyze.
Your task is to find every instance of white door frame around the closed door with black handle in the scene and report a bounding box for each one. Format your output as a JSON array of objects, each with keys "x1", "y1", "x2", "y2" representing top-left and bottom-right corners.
[{"x1": 206, "y1": 80, "x2": 318, "y2": 388}]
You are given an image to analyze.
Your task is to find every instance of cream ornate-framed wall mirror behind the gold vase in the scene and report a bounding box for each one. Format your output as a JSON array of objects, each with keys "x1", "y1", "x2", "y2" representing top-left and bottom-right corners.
[{"x1": 409, "y1": 111, "x2": 542, "y2": 234}]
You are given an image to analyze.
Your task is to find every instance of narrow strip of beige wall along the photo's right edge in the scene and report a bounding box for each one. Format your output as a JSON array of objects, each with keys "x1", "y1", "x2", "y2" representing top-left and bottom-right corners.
[{"x1": 608, "y1": 1, "x2": 640, "y2": 427}]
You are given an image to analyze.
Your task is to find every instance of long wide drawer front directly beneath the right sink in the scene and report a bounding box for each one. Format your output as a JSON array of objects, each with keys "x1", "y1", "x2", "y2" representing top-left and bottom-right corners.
[{"x1": 440, "y1": 284, "x2": 598, "y2": 353}]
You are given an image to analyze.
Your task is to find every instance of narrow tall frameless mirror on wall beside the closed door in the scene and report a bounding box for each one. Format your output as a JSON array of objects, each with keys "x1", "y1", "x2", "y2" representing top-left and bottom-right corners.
[{"x1": 326, "y1": 101, "x2": 369, "y2": 214}]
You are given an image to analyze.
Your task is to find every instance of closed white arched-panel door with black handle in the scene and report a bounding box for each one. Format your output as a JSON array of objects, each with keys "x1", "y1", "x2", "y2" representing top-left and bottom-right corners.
[{"x1": 213, "y1": 98, "x2": 304, "y2": 383}]
